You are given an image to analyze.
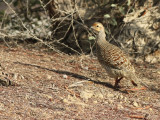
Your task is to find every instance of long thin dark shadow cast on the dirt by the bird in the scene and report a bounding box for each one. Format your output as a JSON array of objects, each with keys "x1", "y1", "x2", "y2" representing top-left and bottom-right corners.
[{"x1": 14, "y1": 62, "x2": 127, "y2": 93}]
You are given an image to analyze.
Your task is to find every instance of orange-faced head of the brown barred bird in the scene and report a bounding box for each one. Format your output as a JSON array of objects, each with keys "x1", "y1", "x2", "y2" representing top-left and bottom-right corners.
[{"x1": 91, "y1": 22, "x2": 104, "y2": 34}]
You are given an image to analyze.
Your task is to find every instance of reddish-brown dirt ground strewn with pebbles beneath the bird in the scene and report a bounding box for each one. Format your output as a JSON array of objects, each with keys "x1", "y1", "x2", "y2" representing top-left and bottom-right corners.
[{"x1": 0, "y1": 45, "x2": 160, "y2": 120}]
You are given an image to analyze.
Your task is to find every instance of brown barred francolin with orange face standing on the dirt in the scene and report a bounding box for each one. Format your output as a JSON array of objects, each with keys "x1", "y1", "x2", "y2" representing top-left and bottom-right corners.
[{"x1": 91, "y1": 22, "x2": 144, "y2": 90}]
